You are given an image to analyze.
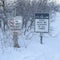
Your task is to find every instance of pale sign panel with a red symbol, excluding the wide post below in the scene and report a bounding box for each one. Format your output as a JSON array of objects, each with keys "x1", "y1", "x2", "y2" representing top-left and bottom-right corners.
[{"x1": 8, "y1": 17, "x2": 23, "y2": 30}]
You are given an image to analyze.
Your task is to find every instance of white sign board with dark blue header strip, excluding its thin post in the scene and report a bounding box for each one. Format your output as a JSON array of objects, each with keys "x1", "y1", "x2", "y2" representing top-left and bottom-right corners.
[{"x1": 34, "y1": 13, "x2": 49, "y2": 33}]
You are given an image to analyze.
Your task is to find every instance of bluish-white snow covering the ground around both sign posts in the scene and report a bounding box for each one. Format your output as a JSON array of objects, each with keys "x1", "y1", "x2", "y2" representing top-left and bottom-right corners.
[{"x1": 0, "y1": 13, "x2": 60, "y2": 60}]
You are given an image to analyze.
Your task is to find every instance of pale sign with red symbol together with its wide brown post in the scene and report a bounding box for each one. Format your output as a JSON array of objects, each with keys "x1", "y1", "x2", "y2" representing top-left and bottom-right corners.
[{"x1": 8, "y1": 16, "x2": 23, "y2": 48}]
